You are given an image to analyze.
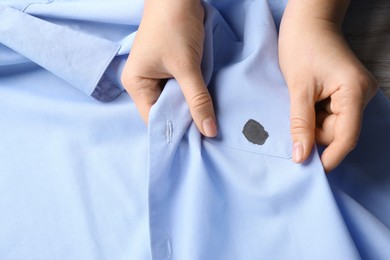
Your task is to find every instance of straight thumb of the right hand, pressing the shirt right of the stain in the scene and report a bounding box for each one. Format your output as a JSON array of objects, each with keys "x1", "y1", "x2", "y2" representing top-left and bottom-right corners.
[{"x1": 290, "y1": 88, "x2": 315, "y2": 163}]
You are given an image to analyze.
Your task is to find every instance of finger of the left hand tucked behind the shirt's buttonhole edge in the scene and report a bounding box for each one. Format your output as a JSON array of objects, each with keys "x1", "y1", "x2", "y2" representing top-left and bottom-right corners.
[{"x1": 122, "y1": 77, "x2": 162, "y2": 124}]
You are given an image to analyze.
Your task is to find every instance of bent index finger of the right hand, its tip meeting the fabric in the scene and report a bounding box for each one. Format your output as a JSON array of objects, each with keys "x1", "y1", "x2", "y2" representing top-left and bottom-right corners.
[{"x1": 321, "y1": 103, "x2": 362, "y2": 172}]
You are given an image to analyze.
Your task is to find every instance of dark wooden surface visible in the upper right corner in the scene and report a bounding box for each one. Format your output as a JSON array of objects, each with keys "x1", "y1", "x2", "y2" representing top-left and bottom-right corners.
[{"x1": 343, "y1": 0, "x2": 390, "y2": 98}]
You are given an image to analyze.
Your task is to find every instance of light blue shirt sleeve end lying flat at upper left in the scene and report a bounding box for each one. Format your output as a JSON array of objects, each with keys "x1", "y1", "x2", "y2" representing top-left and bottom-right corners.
[{"x1": 0, "y1": 5, "x2": 122, "y2": 102}]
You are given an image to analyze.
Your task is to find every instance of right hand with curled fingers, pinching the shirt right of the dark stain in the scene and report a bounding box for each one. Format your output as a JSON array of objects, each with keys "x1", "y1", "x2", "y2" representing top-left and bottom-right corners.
[{"x1": 279, "y1": 0, "x2": 377, "y2": 171}]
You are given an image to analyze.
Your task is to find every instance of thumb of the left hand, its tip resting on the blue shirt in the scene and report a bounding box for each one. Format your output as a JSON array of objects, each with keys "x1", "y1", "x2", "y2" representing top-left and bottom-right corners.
[{"x1": 174, "y1": 68, "x2": 217, "y2": 137}]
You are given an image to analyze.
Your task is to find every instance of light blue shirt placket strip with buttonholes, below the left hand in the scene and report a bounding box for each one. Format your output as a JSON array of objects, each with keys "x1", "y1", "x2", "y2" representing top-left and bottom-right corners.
[{"x1": 148, "y1": 80, "x2": 191, "y2": 259}]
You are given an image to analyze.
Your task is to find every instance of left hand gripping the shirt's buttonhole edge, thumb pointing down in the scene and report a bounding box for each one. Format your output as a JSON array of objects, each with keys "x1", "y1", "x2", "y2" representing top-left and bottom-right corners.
[{"x1": 122, "y1": 0, "x2": 217, "y2": 137}]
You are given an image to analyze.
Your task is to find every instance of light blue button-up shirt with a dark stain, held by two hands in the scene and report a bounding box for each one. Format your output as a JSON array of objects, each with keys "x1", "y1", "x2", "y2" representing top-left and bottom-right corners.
[{"x1": 0, "y1": 0, "x2": 390, "y2": 260}]
